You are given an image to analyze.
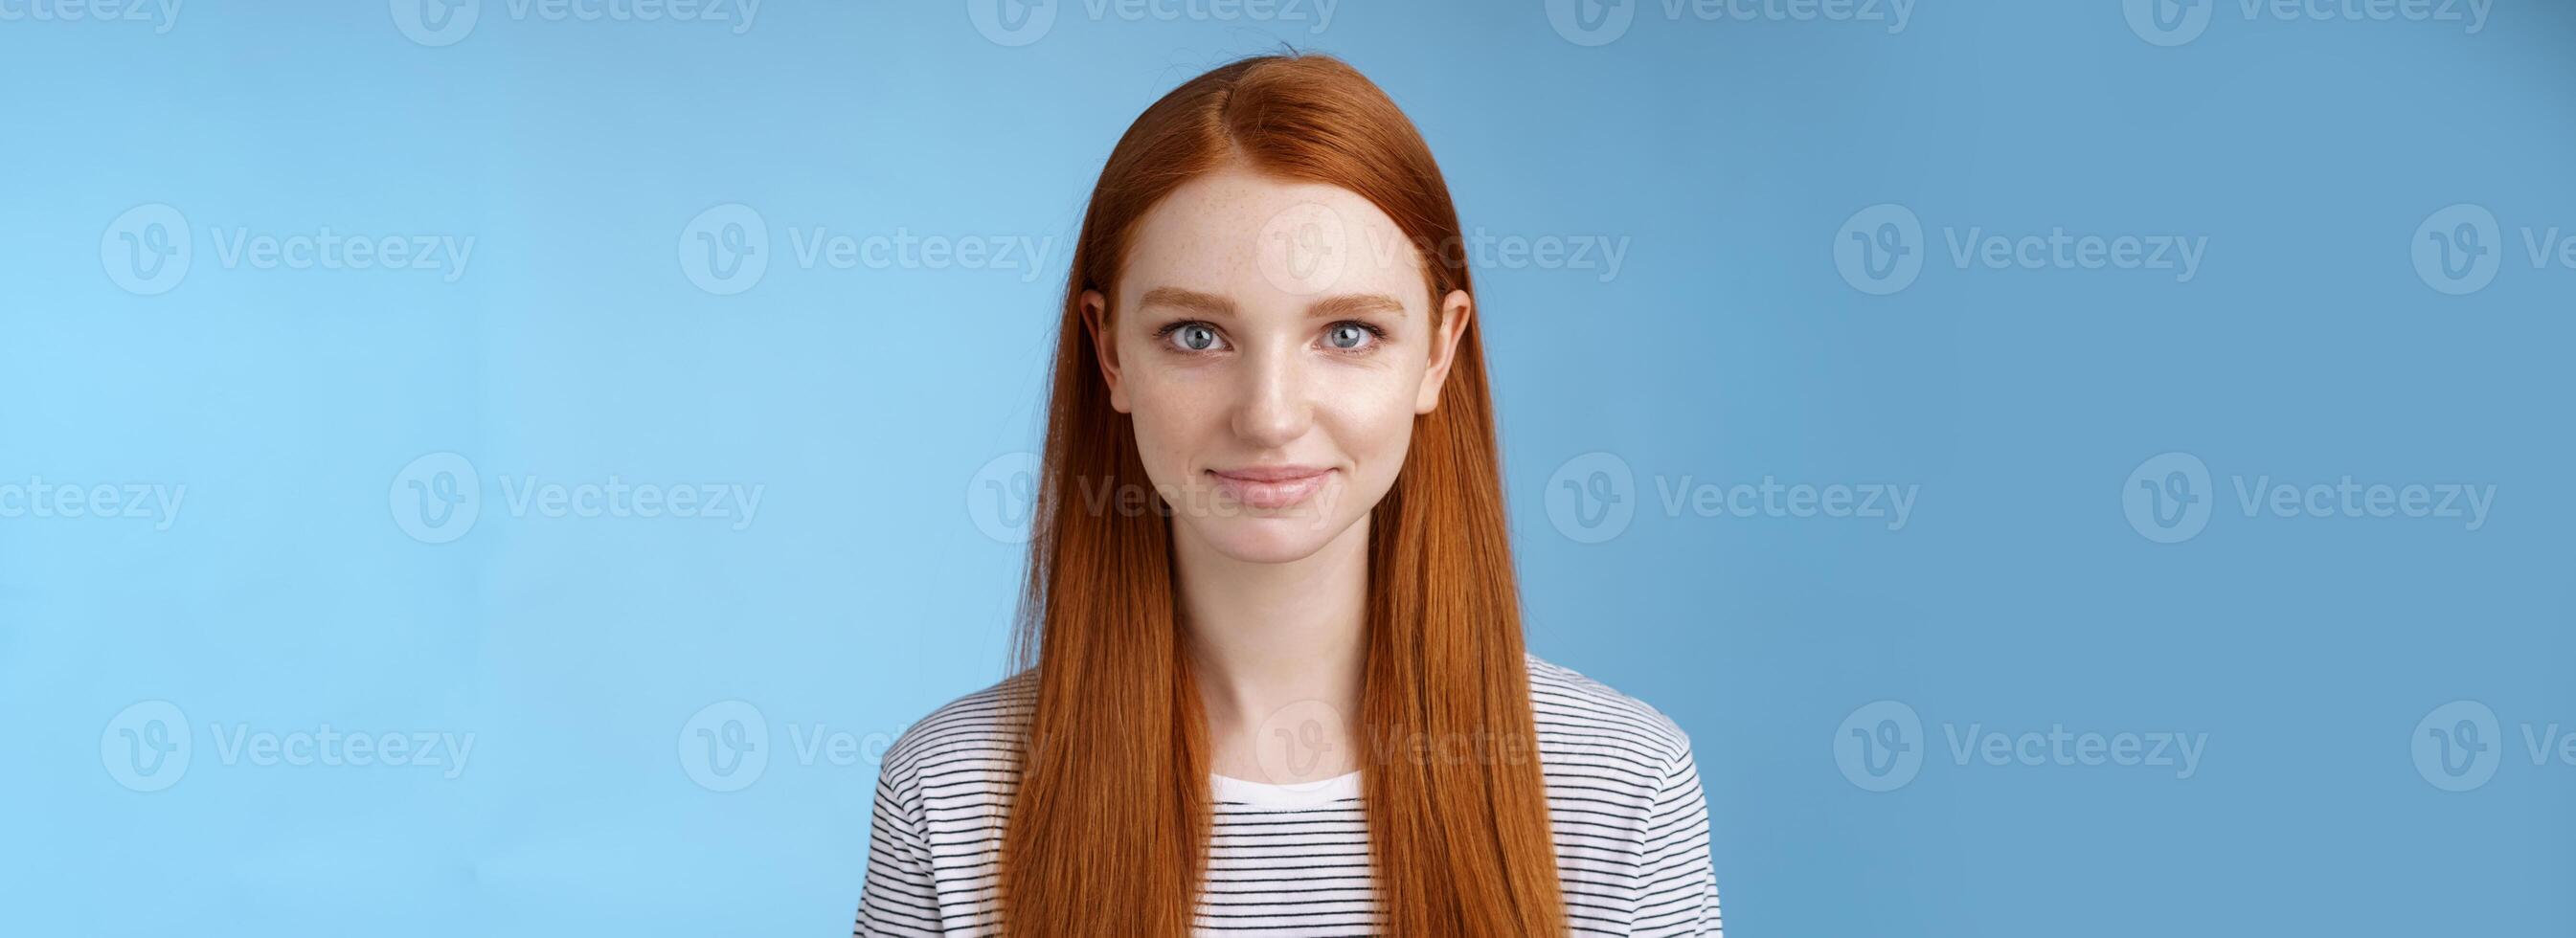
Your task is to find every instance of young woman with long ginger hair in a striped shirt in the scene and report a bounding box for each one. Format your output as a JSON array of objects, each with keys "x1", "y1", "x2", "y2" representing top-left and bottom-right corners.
[{"x1": 858, "y1": 55, "x2": 1718, "y2": 938}]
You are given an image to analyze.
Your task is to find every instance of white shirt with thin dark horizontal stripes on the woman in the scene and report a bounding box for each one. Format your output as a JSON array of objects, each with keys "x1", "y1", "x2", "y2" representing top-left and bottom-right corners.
[{"x1": 855, "y1": 655, "x2": 1718, "y2": 938}]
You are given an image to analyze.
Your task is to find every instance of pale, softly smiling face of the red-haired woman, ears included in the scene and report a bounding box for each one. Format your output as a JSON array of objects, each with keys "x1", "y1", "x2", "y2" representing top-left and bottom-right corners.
[{"x1": 1082, "y1": 170, "x2": 1474, "y2": 562}]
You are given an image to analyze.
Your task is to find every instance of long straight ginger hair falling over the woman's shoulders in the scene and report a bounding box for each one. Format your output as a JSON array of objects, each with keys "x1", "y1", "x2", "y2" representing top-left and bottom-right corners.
[{"x1": 994, "y1": 55, "x2": 1567, "y2": 938}]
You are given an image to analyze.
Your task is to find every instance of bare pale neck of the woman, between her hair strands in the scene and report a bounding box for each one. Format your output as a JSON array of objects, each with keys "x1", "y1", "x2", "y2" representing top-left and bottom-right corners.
[{"x1": 1172, "y1": 515, "x2": 1367, "y2": 768}]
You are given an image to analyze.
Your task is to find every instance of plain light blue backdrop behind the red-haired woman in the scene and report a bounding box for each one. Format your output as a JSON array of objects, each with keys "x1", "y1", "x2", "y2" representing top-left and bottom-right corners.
[{"x1": 0, "y1": 0, "x2": 2576, "y2": 935}]
